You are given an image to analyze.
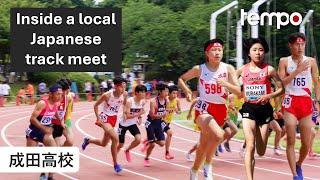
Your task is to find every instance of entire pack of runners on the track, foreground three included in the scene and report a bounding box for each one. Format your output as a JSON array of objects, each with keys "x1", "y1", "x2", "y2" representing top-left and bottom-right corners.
[{"x1": 26, "y1": 33, "x2": 320, "y2": 180}]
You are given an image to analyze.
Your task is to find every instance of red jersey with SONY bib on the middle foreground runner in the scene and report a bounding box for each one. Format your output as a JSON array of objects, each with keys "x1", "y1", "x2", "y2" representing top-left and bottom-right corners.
[{"x1": 241, "y1": 64, "x2": 271, "y2": 103}]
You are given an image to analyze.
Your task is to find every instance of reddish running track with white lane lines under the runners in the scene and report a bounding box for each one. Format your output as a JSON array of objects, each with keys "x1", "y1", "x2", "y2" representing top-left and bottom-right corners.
[{"x1": 0, "y1": 102, "x2": 320, "y2": 180}]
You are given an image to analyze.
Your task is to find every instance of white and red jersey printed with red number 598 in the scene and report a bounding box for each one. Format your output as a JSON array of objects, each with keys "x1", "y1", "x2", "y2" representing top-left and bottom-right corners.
[{"x1": 198, "y1": 62, "x2": 228, "y2": 104}]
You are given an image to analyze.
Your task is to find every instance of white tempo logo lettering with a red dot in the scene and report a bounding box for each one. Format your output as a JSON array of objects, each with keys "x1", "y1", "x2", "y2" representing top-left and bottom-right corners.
[{"x1": 240, "y1": 9, "x2": 302, "y2": 29}]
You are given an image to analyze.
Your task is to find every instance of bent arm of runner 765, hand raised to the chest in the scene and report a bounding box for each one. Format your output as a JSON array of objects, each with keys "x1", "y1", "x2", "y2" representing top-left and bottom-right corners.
[{"x1": 279, "y1": 57, "x2": 310, "y2": 86}]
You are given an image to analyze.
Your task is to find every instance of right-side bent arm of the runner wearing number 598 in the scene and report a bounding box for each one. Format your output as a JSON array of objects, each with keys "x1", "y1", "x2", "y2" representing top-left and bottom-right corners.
[{"x1": 217, "y1": 64, "x2": 241, "y2": 96}]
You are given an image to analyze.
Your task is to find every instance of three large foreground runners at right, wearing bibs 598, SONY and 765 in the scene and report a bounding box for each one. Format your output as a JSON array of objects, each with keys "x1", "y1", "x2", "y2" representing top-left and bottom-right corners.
[{"x1": 179, "y1": 33, "x2": 320, "y2": 180}]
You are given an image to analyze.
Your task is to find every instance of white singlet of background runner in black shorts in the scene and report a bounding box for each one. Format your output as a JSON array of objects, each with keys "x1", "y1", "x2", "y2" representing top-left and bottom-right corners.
[{"x1": 120, "y1": 97, "x2": 146, "y2": 127}]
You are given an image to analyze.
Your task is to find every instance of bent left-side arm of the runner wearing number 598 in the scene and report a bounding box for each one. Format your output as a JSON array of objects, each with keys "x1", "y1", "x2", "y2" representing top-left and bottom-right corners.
[{"x1": 178, "y1": 65, "x2": 200, "y2": 102}]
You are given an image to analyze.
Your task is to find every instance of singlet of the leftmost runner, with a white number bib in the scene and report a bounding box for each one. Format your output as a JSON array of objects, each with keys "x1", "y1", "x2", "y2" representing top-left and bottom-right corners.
[{"x1": 37, "y1": 99, "x2": 58, "y2": 126}]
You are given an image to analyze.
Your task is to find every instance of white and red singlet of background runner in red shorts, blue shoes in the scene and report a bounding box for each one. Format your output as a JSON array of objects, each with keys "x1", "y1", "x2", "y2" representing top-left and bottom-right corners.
[{"x1": 102, "y1": 90, "x2": 124, "y2": 116}]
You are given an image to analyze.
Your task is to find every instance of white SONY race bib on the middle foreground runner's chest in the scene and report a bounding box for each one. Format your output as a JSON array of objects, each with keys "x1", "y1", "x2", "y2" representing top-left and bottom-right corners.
[{"x1": 244, "y1": 84, "x2": 267, "y2": 101}]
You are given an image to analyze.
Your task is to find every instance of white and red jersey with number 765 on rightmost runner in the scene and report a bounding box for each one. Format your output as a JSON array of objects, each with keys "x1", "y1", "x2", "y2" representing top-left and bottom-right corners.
[{"x1": 285, "y1": 56, "x2": 312, "y2": 96}]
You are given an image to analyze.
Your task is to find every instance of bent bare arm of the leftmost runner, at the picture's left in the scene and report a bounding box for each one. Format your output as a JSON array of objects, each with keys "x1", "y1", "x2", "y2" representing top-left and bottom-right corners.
[{"x1": 30, "y1": 100, "x2": 52, "y2": 134}]
